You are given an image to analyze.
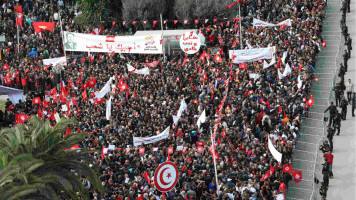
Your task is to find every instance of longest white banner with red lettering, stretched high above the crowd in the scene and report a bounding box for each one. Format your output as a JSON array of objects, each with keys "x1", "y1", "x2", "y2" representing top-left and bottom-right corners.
[{"x1": 63, "y1": 31, "x2": 162, "y2": 54}]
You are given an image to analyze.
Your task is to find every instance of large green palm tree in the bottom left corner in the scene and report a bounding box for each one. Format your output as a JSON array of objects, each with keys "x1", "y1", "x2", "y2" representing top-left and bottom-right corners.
[{"x1": 0, "y1": 118, "x2": 103, "y2": 200}]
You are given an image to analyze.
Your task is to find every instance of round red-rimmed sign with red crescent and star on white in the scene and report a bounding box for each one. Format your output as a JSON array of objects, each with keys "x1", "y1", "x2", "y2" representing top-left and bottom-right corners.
[{"x1": 154, "y1": 161, "x2": 178, "y2": 192}]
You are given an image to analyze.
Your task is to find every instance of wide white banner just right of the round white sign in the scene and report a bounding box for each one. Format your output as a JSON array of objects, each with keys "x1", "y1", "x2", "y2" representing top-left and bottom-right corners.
[{"x1": 229, "y1": 47, "x2": 276, "y2": 63}]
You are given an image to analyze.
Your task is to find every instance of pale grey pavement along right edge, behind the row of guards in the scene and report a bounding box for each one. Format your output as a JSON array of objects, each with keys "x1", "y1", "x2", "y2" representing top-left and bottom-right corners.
[{"x1": 327, "y1": 0, "x2": 356, "y2": 200}]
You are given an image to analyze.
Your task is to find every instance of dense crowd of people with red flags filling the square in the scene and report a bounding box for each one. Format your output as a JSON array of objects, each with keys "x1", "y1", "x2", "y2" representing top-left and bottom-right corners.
[{"x1": 0, "y1": 0, "x2": 326, "y2": 200}]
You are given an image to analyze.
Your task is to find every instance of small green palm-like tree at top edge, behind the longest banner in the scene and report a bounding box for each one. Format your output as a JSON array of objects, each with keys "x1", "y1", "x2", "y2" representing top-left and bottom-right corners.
[{"x1": 74, "y1": 0, "x2": 111, "y2": 28}]
